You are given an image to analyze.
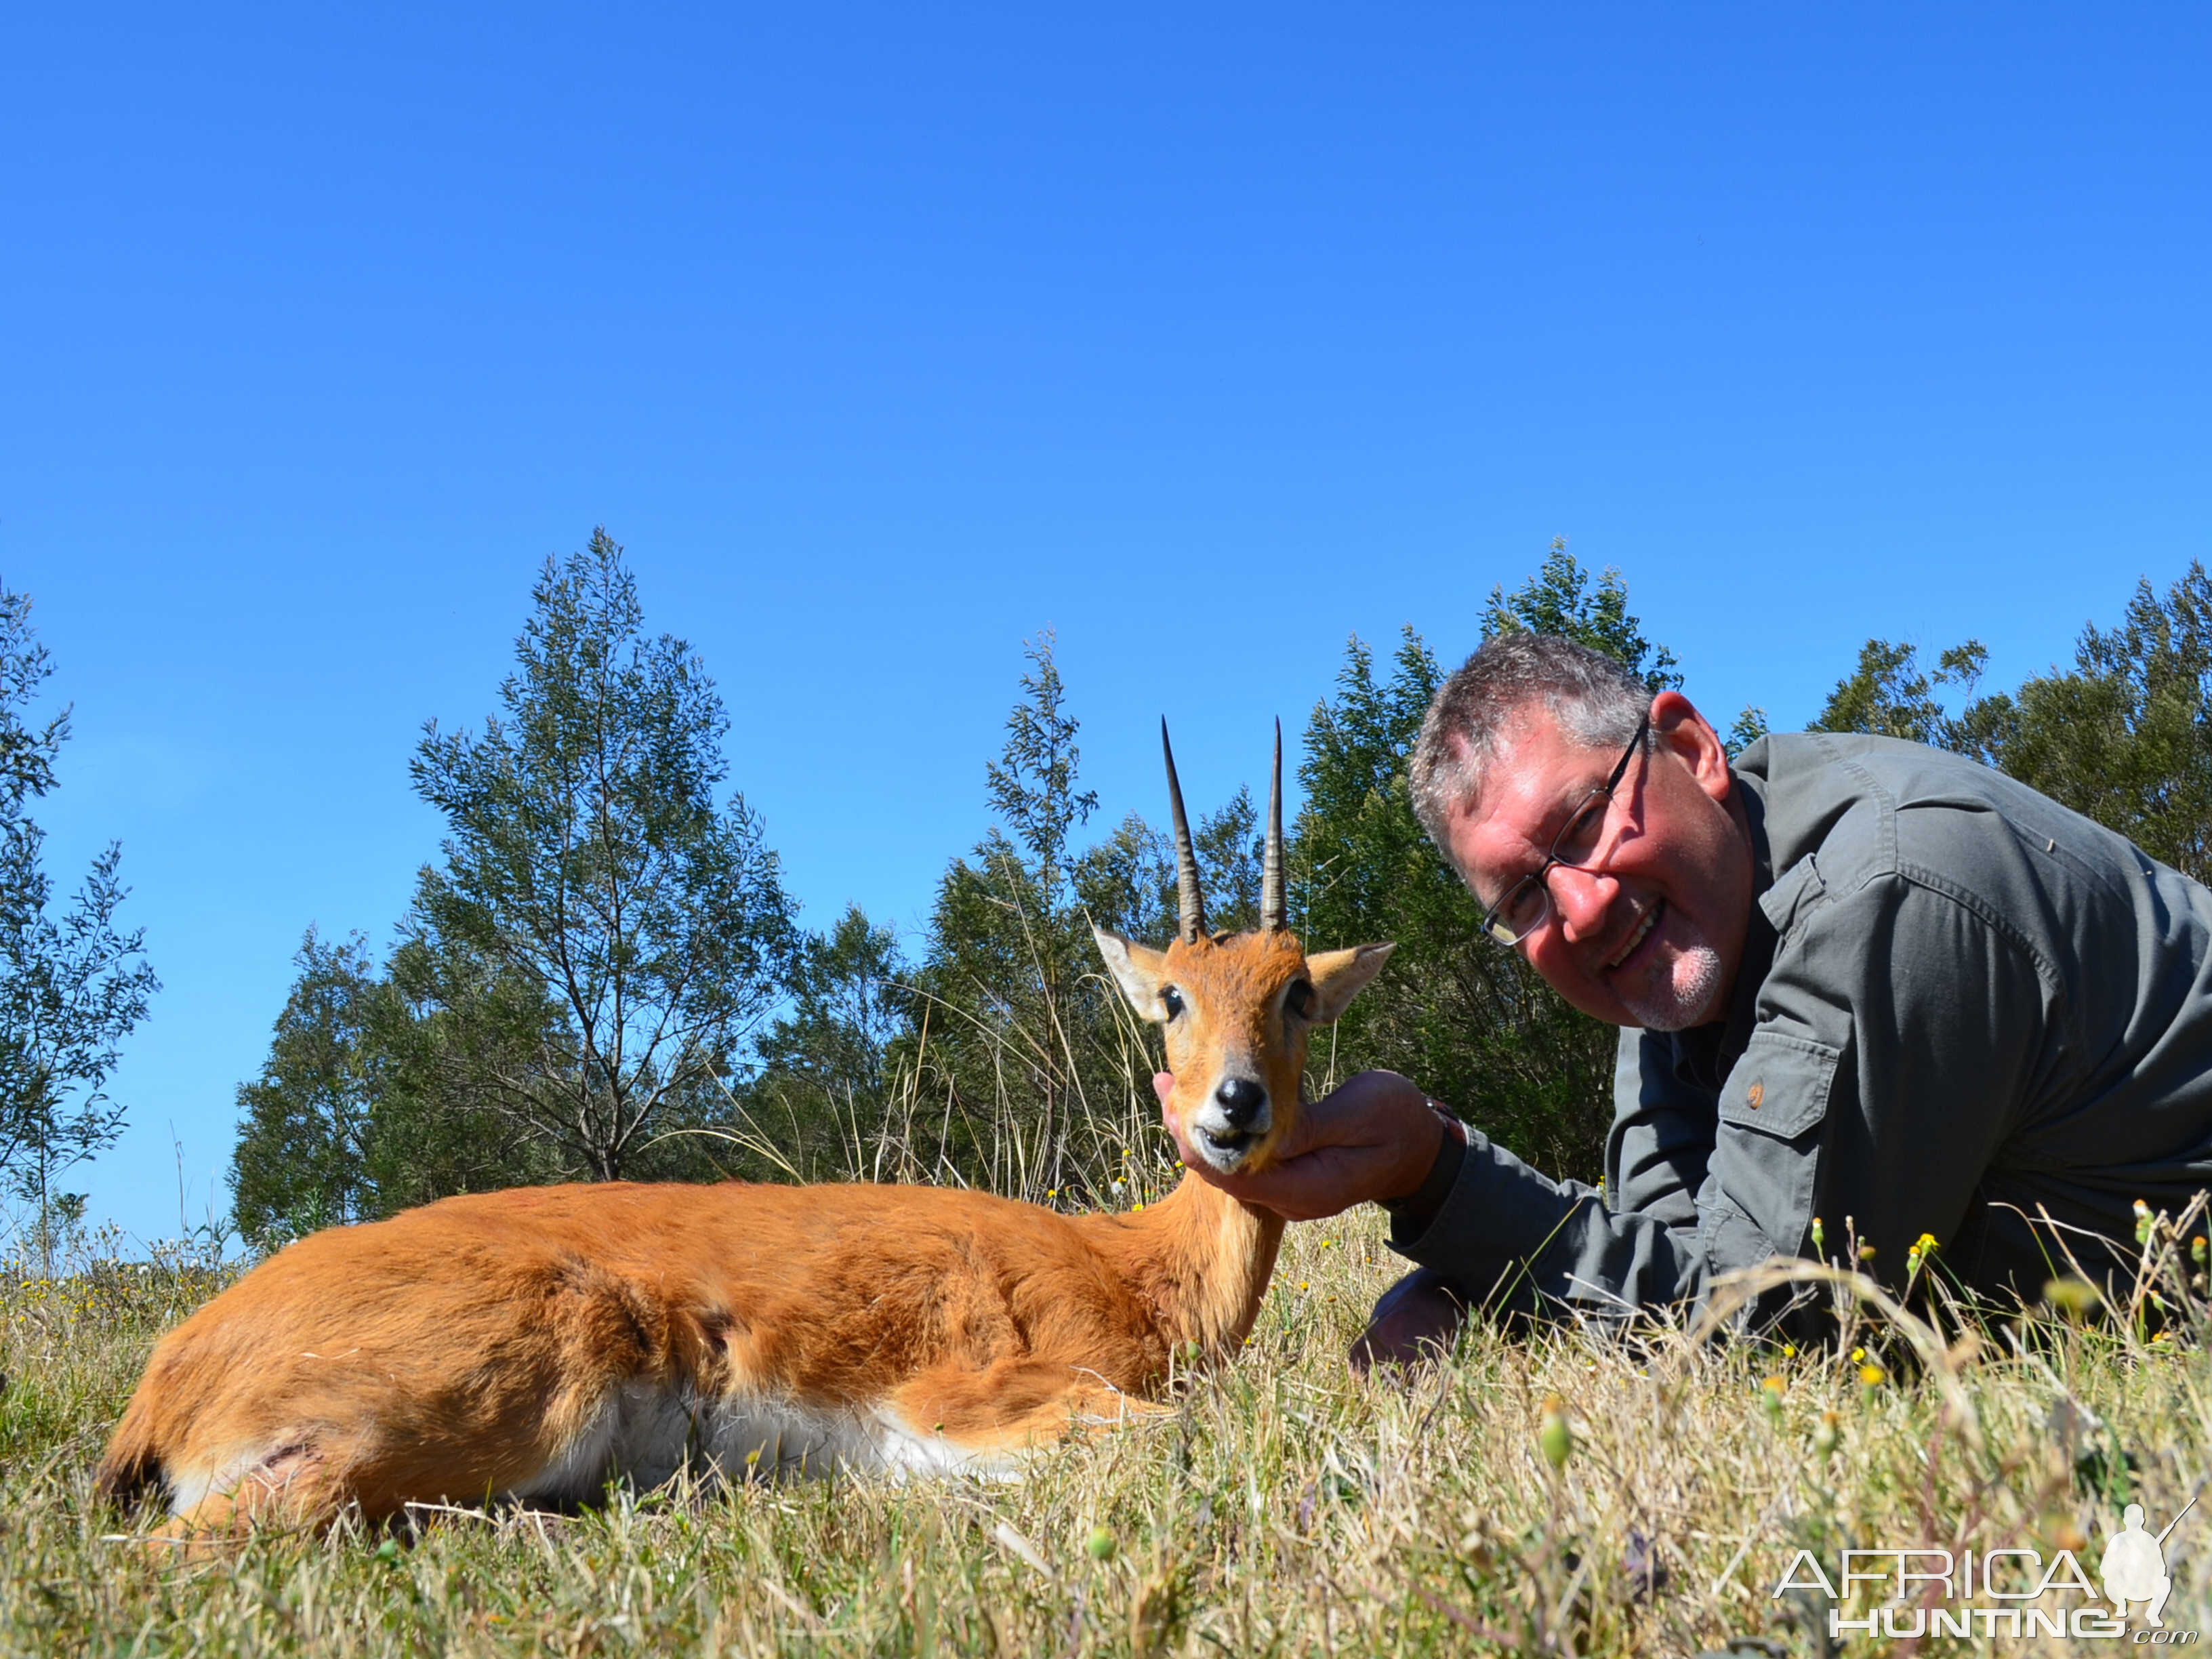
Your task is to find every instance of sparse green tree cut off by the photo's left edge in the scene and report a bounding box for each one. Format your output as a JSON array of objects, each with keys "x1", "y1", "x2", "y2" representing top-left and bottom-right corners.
[{"x1": 0, "y1": 586, "x2": 161, "y2": 1267}]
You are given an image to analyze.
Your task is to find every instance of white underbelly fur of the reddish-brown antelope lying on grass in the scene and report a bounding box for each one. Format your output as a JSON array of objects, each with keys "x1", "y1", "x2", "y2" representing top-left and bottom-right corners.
[{"x1": 506, "y1": 1382, "x2": 1017, "y2": 1500}]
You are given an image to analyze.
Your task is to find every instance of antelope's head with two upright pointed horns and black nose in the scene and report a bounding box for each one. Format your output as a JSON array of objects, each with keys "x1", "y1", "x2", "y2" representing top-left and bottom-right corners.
[{"x1": 1090, "y1": 721, "x2": 1396, "y2": 1174}]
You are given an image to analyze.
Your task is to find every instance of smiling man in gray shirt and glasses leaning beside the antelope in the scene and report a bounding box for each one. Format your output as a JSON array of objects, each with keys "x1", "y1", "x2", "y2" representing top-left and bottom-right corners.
[{"x1": 1159, "y1": 635, "x2": 2212, "y2": 1360}]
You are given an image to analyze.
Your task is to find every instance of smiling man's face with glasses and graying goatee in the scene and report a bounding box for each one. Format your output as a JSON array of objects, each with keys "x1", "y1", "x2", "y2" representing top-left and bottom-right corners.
[{"x1": 1447, "y1": 693, "x2": 1752, "y2": 1031}]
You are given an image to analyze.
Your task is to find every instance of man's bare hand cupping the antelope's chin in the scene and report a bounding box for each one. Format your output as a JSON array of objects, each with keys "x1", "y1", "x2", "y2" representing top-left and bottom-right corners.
[{"x1": 1153, "y1": 1071, "x2": 1444, "y2": 1221}]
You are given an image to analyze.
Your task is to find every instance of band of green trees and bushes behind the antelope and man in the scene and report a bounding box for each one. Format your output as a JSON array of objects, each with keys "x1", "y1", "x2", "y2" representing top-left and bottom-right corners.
[{"x1": 234, "y1": 531, "x2": 2212, "y2": 1241}]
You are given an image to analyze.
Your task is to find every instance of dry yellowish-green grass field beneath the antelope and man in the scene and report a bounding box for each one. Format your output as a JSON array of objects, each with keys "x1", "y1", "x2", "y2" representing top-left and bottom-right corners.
[{"x1": 0, "y1": 1194, "x2": 2212, "y2": 1654}]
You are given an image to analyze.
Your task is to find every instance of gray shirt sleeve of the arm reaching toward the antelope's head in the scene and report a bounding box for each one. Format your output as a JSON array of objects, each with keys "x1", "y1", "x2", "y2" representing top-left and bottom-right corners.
[{"x1": 1391, "y1": 874, "x2": 2044, "y2": 1312}]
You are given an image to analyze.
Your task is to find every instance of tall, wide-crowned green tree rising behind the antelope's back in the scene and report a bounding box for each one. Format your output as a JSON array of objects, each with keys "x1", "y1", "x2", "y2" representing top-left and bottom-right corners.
[{"x1": 407, "y1": 529, "x2": 796, "y2": 1181}]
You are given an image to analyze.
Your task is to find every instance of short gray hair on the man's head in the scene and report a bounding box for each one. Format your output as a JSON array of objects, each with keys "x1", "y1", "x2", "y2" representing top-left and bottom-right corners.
[{"x1": 1411, "y1": 630, "x2": 1652, "y2": 874}]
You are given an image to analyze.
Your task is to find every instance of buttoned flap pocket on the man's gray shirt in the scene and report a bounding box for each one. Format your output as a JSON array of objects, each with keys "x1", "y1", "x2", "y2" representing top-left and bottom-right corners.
[{"x1": 1699, "y1": 1031, "x2": 1843, "y2": 1270}]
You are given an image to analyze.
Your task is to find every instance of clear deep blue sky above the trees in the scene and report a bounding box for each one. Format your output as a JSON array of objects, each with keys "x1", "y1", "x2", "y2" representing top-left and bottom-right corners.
[{"x1": 0, "y1": 5, "x2": 2212, "y2": 1237}]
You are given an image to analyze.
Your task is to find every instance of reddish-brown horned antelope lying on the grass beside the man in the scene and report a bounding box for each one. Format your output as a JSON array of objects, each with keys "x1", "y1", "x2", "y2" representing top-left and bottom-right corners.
[{"x1": 100, "y1": 723, "x2": 1391, "y2": 1535}]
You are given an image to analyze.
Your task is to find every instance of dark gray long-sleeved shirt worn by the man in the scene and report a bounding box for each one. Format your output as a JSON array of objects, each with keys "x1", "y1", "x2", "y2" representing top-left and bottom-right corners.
[{"x1": 1391, "y1": 735, "x2": 2212, "y2": 1336}]
